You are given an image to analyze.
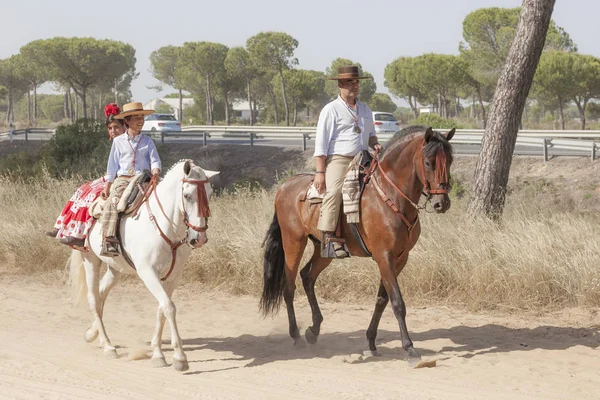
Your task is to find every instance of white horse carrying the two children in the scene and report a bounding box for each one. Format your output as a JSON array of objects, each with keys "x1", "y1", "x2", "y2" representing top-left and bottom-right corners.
[{"x1": 68, "y1": 160, "x2": 218, "y2": 371}]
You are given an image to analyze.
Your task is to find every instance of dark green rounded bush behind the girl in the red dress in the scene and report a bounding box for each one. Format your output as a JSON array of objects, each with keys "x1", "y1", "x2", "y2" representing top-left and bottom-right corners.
[{"x1": 41, "y1": 119, "x2": 111, "y2": 176}]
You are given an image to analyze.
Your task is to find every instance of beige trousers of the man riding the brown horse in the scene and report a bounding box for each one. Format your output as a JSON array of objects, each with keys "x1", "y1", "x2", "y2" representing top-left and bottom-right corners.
[{"x1": 317, "y1": 154, "x2": 354, "y2": 232}]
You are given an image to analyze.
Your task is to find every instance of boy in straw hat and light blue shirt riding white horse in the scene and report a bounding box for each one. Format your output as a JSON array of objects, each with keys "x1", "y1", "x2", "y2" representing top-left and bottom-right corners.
[{"x1": 101, "y1": 102, "x2": 161, "y2": 256}]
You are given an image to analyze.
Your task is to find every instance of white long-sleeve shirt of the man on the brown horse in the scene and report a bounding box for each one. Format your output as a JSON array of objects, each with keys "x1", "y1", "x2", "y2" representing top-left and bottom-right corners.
[{"x1": 315, "y1": 96, "x2": 375, "y2": 157}]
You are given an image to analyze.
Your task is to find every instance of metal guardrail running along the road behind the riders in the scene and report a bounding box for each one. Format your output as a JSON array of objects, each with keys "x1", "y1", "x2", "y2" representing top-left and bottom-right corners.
[{"x1": 0, "y1": 125, "x2": 600, "y2": 161}]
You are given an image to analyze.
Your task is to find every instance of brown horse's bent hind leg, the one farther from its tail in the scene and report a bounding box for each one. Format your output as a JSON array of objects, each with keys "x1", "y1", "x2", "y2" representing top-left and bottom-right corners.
[{"x1": 300, "y1": 244, "x2": 332, "y2": 344}]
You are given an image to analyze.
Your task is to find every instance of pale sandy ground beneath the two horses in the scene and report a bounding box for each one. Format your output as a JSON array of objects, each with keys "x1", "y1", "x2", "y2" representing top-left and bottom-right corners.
[{"x1": 0, "y1": 277, "x2": 600, "y2": 400}]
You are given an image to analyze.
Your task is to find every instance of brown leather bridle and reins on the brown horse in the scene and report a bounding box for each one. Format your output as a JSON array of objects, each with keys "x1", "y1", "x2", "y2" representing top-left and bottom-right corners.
[{"x1": 365, "y1": 141, "x2": 449, "y2": 233}]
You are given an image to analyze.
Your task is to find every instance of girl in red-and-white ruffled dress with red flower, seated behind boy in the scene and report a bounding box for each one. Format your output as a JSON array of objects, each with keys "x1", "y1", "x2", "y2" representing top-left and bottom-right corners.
[{"x1": 46, "y1": 103, "x2": 125, "y2": 247}]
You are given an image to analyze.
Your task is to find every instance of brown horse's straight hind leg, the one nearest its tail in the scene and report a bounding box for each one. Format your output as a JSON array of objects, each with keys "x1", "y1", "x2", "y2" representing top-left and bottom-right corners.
[{"x1": 283, "y1": 237, "x2": 308, "y2": 345}]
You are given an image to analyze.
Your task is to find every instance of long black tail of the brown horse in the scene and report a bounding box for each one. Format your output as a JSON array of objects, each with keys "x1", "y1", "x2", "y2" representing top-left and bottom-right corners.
[{"x1": 260, "y1": 212, "x2": 285, "y2": 316}]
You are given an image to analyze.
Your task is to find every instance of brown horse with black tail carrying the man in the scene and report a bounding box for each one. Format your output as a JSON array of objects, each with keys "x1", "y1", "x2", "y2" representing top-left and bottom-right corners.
[{"x1": 260, "y1": 126, "x2": 454, "y2": 363}]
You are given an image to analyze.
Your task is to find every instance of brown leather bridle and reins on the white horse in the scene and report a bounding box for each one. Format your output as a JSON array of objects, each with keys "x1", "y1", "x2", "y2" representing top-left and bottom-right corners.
[{"x1": 144, "y1": 176, "x2": 210, "y2": 281}]
